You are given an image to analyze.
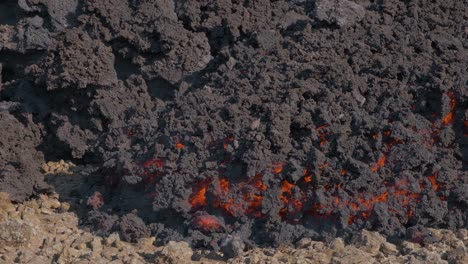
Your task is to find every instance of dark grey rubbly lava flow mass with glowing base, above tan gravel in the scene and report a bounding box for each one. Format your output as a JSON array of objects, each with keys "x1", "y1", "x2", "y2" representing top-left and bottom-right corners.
[{"x1": 0, "y1": 0, "x2": 468, "y2": 250}]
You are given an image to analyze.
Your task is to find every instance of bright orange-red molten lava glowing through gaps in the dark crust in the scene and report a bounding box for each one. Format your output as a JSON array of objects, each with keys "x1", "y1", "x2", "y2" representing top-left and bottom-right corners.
[{"x1": 187, "y1": 120, "x2": 458, "y2": 230}]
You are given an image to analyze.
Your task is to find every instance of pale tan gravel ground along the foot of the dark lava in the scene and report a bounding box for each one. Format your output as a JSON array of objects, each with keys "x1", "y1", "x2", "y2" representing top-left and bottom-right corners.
[{"x1": 0, "y1": 190, "x2": 468, "y2": 264}]
